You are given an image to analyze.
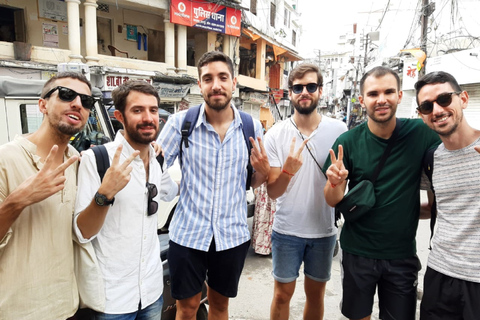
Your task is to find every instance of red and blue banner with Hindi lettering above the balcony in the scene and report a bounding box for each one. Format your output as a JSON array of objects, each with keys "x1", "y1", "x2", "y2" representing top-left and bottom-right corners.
[{"x1": 170, "y1": 0, "x2": 242, "y2": 37}]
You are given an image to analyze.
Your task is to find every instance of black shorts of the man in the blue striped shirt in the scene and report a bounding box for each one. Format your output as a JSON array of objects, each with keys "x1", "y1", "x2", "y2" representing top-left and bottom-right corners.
[{"x1": 168, "y1": 240, "x2": 250, "y2": 300}]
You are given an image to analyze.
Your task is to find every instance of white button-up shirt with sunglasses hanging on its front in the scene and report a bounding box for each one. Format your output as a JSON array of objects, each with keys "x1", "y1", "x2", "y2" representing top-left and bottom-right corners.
[{"x1": 74, "y1": 132, "x2": 178, "y2": 314}]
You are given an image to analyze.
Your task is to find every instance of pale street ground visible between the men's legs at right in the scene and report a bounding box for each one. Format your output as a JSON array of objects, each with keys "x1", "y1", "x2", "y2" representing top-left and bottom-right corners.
[{"x1": 230, "y1": 201, "x2": 430, "y2": 320}]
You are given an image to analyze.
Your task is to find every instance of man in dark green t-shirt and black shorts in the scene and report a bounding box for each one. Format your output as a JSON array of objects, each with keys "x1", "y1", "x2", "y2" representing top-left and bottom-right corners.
[{"x1": 324, "y1": 67, "x2": 439, "y2": 320}]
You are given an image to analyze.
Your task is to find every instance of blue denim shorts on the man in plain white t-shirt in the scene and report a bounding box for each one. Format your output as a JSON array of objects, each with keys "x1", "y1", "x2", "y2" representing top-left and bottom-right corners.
[{"x1": 272, "y1": 231, "x2": 337, "y2": 283}]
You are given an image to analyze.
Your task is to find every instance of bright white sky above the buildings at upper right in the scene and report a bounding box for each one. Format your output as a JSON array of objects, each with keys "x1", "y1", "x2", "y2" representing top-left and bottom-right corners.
[{"x1": 298, "y1": 0, "x2": 480, "y2": 58}]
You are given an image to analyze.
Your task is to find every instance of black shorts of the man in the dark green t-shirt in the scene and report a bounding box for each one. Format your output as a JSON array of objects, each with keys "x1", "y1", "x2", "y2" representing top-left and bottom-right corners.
[{"x1": 341, "y1": 252, "x2": 421, "y2": 320}]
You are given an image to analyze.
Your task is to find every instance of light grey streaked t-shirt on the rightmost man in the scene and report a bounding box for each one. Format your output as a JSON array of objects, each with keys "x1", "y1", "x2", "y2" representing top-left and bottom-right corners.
[{"x1": 428, "y1": 139, "x2": 480, "y2": 283}]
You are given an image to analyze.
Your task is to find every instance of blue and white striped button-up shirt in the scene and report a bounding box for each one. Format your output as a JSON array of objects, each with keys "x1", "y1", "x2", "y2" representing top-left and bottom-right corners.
[{"x1": 158, "y1": 104, "x2": 262, "y2": 251}]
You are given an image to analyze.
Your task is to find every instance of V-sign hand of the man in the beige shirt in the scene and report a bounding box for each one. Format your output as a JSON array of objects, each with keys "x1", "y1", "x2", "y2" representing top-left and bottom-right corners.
[{"x1": 18, "y1": 145, "x2": 78, "y2": 205}]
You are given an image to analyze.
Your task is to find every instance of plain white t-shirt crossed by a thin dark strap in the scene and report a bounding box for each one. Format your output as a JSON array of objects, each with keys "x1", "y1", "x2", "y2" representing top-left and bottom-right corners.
[{"x1": 265, "y1": 116, "x2": 347, "y2": 238}]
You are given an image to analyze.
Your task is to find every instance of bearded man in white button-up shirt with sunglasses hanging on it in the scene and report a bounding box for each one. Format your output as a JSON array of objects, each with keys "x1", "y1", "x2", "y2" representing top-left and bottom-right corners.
[{"x1": 74, "y1": 80, "x2": 178, "y2": 320}]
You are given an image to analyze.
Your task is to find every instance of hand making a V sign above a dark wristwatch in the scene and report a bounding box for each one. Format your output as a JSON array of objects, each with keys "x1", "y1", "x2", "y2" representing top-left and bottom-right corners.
[{"x1": 98, "y1": 145, "x2": 140, "y2": 200}]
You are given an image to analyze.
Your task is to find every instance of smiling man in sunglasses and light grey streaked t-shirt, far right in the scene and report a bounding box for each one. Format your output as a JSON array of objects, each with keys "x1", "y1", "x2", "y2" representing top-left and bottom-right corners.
[{"x1": 415, "y1": 71, "x2": 480, "y2": 320}]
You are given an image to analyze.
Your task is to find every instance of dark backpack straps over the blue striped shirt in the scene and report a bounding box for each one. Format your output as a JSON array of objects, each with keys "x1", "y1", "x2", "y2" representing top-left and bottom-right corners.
[{"x1": 178, "y1": 105, "x2": 255, "y2": 190}]
